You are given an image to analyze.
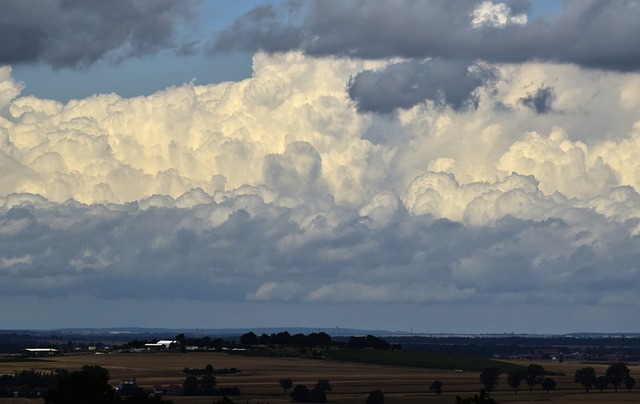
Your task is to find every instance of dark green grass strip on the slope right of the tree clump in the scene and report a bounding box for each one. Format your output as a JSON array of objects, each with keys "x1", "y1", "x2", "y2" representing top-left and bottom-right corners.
[{"x1": 324, "y1": 349, "x2": 523, "y2": 372}]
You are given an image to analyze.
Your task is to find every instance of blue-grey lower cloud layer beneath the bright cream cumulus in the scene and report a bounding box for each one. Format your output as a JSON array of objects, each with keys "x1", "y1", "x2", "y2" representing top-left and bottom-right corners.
[{"x1": 0, "y1": 189, "x2": 640, "y2": 304}]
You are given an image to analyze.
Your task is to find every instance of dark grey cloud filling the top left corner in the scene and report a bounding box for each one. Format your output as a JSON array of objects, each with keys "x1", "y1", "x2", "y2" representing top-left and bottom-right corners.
[{"x1": 0, "y1": 0, "x2": 195, "y2": 67}]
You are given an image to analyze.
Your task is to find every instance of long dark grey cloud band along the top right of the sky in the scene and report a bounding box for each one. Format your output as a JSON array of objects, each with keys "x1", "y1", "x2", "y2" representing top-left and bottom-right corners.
[{"x1": 211, "y1": 0, "x2": 640, "y2": 71}]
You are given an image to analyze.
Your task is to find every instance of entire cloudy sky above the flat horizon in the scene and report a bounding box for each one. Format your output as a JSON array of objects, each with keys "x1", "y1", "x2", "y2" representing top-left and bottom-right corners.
[{"x1": 0, "y1": 0, "x2": 640, "y2": 333}]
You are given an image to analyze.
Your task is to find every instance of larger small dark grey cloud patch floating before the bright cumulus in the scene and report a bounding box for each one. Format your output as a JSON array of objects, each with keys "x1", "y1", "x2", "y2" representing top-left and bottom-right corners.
[{"x1": 348, "y1": 59, "x2": 496, "y2": 113}]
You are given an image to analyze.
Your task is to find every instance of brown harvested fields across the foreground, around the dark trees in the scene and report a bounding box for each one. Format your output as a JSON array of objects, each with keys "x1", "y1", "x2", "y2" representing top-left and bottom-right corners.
[{"x1": 0, "y1": 352, "x2": 640, "y2": 404}]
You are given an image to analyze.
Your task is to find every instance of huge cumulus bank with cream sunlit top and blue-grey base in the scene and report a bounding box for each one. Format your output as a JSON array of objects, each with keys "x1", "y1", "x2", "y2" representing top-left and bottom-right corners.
[{"x1": 0, "y1": 53, "x2": 640, "y2": 332}]
